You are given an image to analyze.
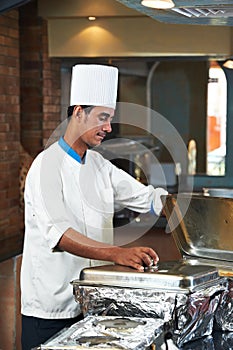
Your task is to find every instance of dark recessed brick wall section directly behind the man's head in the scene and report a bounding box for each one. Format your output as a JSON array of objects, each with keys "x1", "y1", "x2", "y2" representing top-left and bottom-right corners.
[{"x1": 19, "y1": 1, "x2": 61, "y2": 157}]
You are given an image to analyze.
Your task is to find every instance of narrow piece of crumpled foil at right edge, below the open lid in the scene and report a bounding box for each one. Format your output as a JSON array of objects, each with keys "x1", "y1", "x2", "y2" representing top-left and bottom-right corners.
[{"x1": 215, "y1": 278, "x2": 233, "y2": 332}]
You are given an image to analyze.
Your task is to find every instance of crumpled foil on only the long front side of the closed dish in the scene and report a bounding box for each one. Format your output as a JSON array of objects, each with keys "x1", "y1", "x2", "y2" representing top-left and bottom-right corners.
[{"x1": 74, "y1": 285, "x2": 188, "y2": 321}]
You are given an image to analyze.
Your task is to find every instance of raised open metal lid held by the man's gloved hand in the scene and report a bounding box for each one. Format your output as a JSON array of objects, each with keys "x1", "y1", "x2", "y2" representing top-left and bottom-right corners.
[{"x1": 162, "y1": 194, "x2": 233, "y2": 267}]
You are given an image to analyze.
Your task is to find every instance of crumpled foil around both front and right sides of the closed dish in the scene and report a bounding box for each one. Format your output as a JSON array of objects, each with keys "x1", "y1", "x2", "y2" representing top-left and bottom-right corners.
[{"x1": 74, "y1": 279, "x2": 226, "y2": 347}]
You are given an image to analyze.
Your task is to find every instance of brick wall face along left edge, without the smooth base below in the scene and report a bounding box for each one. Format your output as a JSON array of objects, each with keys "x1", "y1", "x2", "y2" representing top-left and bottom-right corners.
[{"x1": 0, "y1": 11, "x2": 22, "y2": 258}]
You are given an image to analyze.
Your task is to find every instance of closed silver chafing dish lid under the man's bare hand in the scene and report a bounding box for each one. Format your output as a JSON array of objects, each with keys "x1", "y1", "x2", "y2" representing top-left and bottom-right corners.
[{"x1": 72, "y1": 260, "x2": 219, "y2": 293}]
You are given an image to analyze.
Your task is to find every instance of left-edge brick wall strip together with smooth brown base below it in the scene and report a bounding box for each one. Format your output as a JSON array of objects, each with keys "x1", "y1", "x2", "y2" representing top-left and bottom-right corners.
[{"x1": 0, "y1": 6, "x2": 22, "y2": 350}]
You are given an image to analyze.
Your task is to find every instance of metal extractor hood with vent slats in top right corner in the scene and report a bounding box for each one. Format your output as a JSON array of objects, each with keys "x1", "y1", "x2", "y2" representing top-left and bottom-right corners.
[{"x1": 117, "y1": 0, "x2": 233, "y2": 26}]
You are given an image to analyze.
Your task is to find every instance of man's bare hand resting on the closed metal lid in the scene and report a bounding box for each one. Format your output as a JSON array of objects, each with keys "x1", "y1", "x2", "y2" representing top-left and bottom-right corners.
[{"x1": 113, "y1": 247, "x2": 159, "y2": 271}]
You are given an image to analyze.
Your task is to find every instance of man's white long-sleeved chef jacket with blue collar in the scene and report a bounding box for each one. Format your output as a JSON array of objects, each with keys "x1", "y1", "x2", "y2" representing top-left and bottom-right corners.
[{"x1": 21, "y1": 138, "x2": 167, "y2": 319}]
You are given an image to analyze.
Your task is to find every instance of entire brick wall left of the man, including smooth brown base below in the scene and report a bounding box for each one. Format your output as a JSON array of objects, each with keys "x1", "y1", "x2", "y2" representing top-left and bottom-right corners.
[{"x1": 0, "y1": 1, "x2": 61, "y2": 350}]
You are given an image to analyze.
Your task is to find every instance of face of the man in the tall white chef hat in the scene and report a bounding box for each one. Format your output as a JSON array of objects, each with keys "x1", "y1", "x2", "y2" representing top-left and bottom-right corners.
[{"x1": 78, "y1": 106, "x2": 115, "y2": 147}]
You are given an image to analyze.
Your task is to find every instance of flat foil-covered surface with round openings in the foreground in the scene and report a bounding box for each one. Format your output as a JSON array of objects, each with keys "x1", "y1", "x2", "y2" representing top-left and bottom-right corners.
[{"x1": 41, "y1": 316, "x2": 164, "y2": 350}]
